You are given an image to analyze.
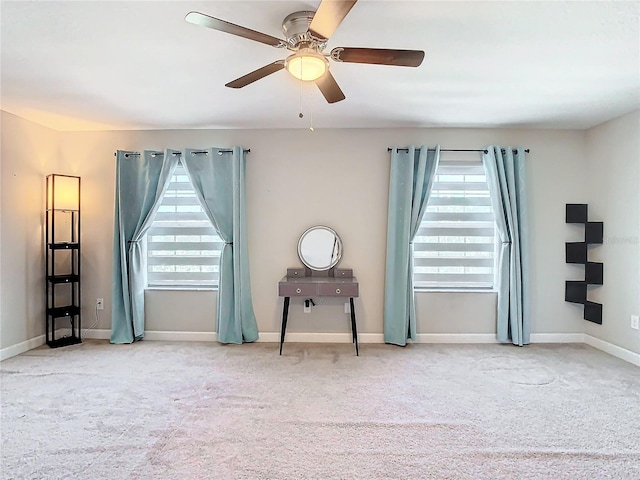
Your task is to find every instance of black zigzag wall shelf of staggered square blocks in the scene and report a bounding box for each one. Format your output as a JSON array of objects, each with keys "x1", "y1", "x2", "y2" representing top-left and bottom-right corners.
[{"x1": 564, "y1": 203, "x2": 604, "y2": 325}]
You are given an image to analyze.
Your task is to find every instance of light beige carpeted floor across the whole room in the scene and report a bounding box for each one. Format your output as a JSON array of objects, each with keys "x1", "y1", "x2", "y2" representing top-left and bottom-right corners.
[{"x1": 0, "y1": 341, "x2": 640, "y2": 480}]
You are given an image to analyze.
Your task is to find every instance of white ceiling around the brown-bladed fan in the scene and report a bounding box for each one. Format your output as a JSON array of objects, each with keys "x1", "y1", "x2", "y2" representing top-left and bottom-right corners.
[{"x1": 0, "y1": 0, "x2": 640, "y2": 131}]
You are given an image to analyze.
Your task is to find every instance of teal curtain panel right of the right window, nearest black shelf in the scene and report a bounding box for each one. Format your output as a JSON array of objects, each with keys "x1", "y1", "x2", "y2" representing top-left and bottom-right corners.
[{"x1": 482, "y1": 146, "x2": 531, "y2": 346}]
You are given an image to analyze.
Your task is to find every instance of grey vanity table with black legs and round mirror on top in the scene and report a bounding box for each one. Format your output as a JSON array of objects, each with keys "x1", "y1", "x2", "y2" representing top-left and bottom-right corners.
[{"x1": 278, "y1": 226, "x2": 360, "y2": 355}]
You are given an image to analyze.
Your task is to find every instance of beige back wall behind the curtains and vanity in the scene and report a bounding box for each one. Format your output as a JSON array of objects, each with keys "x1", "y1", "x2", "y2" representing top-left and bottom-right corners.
[{"x1": 52, "y1": 125, "x2": 587, "y2": 340}]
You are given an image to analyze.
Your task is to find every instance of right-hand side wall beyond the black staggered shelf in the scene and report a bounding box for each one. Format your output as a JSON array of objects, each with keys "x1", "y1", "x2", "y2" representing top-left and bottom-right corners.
[{"x1": 585, "y1": 111, "x2": 640, "y2": 353}]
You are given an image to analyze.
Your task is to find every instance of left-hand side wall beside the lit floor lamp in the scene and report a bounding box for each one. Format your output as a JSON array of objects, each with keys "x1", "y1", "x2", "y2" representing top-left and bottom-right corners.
[{"x1": 0, "y1": 112, "x2": 61, "y2": 349}]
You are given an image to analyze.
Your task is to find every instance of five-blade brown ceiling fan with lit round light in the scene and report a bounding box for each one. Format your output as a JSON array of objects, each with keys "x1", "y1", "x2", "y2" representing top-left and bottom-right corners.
[{"x1": 185, "y1": 0, "x2": 424, "y2": 103}]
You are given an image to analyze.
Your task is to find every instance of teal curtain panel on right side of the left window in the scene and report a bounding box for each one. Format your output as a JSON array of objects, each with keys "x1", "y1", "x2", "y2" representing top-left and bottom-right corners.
[{"x1": 182, "y1": 147, "x2": 258, "y2": 343}]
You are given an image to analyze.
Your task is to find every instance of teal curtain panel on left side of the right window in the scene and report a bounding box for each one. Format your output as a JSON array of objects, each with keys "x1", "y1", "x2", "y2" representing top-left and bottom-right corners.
[{"x1": 384, "y1": 145, "x2": 440, "y2": 346}]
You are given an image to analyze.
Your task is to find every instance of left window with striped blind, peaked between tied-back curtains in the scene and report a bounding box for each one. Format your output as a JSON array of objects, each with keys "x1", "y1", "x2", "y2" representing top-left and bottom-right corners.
[{"x1": 146, "y1": 163, "x2": 223, "y2": 287}]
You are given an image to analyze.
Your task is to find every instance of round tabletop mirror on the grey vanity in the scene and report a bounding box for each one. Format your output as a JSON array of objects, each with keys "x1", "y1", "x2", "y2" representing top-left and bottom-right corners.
[{"x1": 298, "y1": 226, "x2": 342, "y2": 271}]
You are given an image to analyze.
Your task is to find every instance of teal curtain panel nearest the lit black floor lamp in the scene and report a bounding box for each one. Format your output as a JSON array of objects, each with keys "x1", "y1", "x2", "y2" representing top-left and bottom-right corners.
[{"x1": 111, "y1": 150, "x2": 178, "y2": 343}]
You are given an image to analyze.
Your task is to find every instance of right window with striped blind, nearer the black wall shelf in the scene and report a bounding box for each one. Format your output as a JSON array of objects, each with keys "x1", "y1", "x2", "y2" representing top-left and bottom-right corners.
[{"x1": 413, "y1": 160, "x2": 496, "y2": 289}]
